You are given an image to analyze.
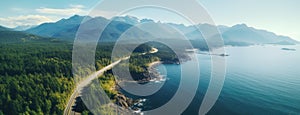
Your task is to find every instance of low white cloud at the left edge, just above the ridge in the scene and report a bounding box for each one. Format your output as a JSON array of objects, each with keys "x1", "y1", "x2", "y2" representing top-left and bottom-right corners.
[{"x1": 0, "y1": 15, "x2": 55, "y2": 27}]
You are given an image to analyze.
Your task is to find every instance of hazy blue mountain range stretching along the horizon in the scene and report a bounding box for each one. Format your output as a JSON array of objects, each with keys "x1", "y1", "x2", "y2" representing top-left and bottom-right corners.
[{"x1": 0, "y1": 15, "x2": 299, "y2": 46}]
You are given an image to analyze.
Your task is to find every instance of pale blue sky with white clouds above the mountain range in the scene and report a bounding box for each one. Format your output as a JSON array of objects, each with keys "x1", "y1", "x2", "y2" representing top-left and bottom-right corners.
[{"x1": 0, "y1": 0, "x2": 300, "y2": 41}]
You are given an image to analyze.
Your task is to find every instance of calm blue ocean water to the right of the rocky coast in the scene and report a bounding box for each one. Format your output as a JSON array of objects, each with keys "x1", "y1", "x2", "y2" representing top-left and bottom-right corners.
[{"x1": 120, "y1": 45, "x2": 300, "y2": 115}]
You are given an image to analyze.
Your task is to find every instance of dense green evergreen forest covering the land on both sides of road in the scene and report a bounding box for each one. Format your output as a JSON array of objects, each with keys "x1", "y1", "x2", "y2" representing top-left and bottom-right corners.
[{"x1": 0, "y1": 27, "x2": 184, "y2": 115}]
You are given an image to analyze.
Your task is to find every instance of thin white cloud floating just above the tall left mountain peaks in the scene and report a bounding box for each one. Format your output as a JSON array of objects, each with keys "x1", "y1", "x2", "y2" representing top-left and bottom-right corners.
[{"x1": 36, "y1": 4, "x2": 86, "y2": 16}]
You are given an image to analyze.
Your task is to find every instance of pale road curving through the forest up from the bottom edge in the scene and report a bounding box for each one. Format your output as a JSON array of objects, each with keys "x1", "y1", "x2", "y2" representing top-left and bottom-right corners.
[{"x1": 64, "y1": 56, "x2": 130, "y2": 115}]
